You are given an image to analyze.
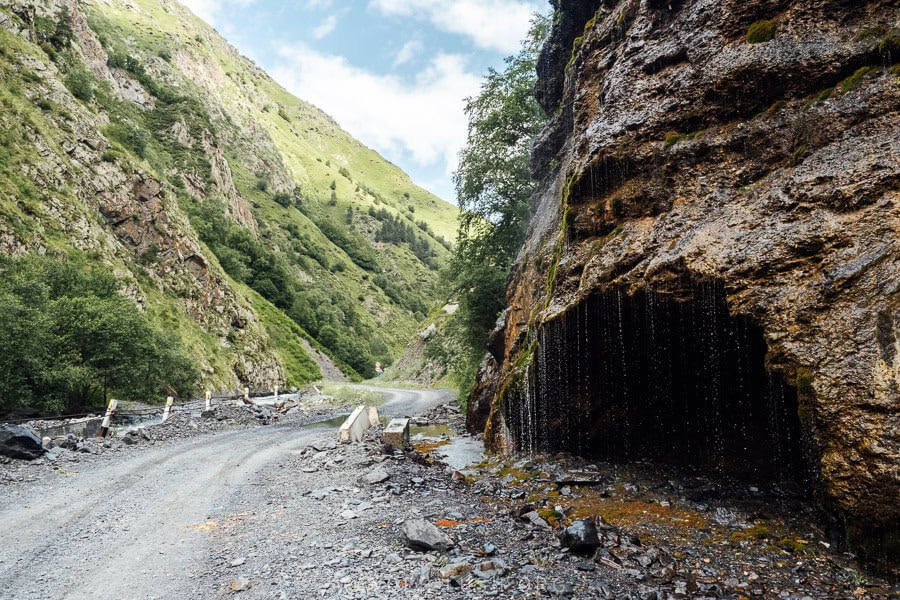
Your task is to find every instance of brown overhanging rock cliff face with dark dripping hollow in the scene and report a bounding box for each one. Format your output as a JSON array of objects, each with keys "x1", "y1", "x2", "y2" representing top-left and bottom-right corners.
[{"x1": 470, "y1": 0, "x2": 900, "y2": 560}]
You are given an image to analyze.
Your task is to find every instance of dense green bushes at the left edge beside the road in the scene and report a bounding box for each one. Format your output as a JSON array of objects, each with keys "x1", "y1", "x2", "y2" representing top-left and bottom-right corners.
[{"x1": 0, "y1": 256, "x2": 198, "y2": 413}]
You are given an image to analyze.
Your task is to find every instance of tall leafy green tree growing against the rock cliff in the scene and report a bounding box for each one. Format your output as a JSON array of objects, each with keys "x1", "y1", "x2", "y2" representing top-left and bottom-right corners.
[{"x1": 446, "y1": 15, "x2": 549, "y2": 392}]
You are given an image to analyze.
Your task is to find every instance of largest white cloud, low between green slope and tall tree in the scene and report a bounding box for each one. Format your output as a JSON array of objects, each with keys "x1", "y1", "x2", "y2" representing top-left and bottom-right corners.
[{"x1": 271, "y1": 45, "x2": 481, "y2": 174}]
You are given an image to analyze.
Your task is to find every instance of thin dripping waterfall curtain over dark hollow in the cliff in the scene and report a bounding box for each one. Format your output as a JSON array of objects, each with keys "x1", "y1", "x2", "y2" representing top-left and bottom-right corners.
[{"x1": 506, "y1": 280, "x2": 803, "y2": 481}]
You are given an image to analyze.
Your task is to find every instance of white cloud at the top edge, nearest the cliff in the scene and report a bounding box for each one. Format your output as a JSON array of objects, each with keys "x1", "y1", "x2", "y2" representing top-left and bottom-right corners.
[{"x1": 369, "y1": 0, "x2": 546, "y2": 54}]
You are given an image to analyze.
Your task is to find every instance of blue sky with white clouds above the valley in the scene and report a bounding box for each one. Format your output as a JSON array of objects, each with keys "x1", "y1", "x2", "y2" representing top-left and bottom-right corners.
[{"x1": 175, "y1": 0, "x2": 549, "y2": 203}]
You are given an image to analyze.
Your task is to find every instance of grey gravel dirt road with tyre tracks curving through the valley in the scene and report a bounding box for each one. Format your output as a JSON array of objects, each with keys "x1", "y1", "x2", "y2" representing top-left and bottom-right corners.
[{"x1": 0, "y1": 390, "x2": 447, "y2": 600}]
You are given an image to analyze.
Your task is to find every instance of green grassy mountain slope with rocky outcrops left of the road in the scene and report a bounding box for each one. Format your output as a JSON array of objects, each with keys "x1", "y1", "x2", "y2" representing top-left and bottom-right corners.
[{"x1": 0, "y1": 0, "x2": 456, "y2": 394}]
